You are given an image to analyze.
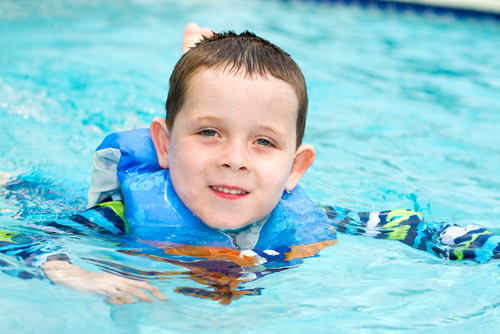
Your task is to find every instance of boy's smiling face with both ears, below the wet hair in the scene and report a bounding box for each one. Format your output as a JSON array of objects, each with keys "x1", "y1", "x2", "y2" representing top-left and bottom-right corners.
[{"x1": 151, "y1": 70, "x2": 314, "y2": 229}]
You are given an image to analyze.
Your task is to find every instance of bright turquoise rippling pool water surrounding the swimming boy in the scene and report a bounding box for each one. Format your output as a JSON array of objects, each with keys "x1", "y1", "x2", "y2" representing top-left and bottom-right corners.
[{"x1": 0, "y1": 0, "x2": 500, "y2": 333}]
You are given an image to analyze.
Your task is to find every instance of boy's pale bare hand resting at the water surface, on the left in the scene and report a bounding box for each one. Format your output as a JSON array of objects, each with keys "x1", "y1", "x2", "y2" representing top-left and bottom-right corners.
[{"x1": 42, "y1": 261, "x2": 168, "y2": 304}]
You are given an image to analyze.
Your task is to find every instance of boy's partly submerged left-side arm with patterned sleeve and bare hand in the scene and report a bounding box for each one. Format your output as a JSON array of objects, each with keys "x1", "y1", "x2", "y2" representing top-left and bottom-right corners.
[{"x1": 0, "y1": 205, "x2": 167, "y2": 304}]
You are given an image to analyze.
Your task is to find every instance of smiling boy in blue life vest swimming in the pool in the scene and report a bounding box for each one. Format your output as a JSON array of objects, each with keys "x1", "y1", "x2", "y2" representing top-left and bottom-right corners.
[{"x1": 3, "y1": 25, "x2": 499, "y2": 304}]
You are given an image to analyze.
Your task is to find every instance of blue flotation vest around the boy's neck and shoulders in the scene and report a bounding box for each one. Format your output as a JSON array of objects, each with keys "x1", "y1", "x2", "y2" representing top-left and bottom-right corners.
[{"x1": 89, "y1": 129, "x2": 337, "y2": 257}]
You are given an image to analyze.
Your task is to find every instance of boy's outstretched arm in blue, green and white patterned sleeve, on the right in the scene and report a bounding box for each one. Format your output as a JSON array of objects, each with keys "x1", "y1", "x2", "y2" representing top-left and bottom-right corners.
[{"x1": 324, "y1": 207, "x2": 500, "y2": 263}]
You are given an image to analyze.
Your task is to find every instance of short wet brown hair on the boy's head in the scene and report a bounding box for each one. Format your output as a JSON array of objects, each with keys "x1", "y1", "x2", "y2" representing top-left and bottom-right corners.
[{"x1": 166, "y1": 31, "x2": 307, "y2": 148}]
